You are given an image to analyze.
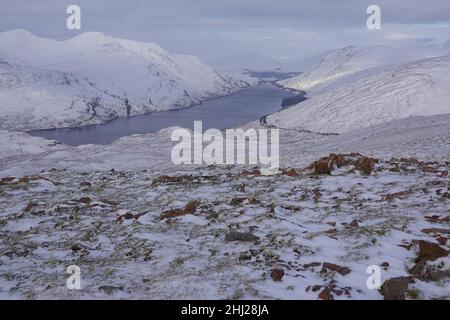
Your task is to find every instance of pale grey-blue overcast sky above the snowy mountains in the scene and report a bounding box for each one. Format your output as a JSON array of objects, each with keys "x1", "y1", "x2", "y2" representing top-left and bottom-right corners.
[{"x1": 0, "y1": 0, "x2": 450, "y2": 61}]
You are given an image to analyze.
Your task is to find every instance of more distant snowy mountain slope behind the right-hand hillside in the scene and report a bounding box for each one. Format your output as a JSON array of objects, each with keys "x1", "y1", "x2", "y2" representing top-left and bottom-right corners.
[{"x1": 279, "y1": 46, "x2": 443, "y2": 91}]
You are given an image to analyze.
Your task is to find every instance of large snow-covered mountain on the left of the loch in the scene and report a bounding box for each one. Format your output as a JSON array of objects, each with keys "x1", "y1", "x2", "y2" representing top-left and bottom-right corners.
[{"x1": 0, "y1": 29, "x2": 253, "y2": 130}]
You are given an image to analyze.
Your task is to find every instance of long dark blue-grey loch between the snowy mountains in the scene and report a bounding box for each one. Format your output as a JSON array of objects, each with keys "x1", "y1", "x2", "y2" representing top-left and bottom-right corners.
[{"x1": 29, "y1": 84, "x2": 292, "y2": 146}]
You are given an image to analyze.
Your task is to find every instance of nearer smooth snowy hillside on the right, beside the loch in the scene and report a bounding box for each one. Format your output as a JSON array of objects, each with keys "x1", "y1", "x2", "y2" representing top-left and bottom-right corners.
[{"x1": 267, "y1": 56, "x2": 450, "y2": 133}]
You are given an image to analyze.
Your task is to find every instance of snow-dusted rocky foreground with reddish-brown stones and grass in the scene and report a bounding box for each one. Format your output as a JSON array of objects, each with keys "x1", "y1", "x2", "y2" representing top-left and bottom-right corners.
[{"x1": 0, "y1": 154, "x2": 450, "y2": 300}]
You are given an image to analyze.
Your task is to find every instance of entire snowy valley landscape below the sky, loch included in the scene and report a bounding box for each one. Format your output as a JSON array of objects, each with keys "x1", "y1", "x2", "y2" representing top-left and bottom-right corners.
[{"x1": 0, "y1": 30, "x2": 450, "y2": 300}]
